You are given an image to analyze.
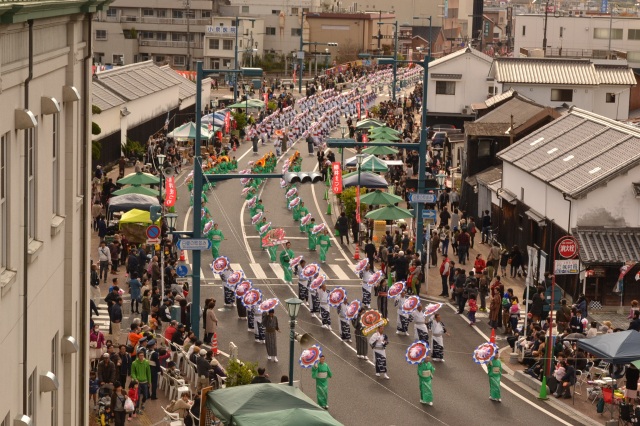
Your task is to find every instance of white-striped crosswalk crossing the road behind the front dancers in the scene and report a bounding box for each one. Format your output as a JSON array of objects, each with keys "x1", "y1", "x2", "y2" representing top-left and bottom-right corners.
[{"x1": 200, "y1": 263, "x2": 360, "y2": 283}]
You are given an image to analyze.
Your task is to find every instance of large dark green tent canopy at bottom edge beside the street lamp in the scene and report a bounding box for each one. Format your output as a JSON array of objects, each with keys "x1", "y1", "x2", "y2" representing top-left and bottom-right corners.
[{"x1": 206, "y1": 383, "x2": 342, "y2": 426}]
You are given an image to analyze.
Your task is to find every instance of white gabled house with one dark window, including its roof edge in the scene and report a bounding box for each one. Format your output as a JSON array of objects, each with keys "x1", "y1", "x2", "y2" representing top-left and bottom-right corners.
[{"x1": 427, "y1": 47, "x2": 492, "y2": 117}]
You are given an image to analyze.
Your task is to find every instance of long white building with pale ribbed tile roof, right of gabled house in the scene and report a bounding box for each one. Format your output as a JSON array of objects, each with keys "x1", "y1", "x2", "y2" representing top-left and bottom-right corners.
[{"x1": 489, "y1": 58, "x2": 636, "y2": 120}]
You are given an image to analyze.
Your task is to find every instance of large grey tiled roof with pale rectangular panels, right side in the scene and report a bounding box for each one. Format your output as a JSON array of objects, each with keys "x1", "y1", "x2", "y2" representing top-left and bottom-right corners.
[{"x1": 498, "y1": 107, "x2": 640, "y2": 198}]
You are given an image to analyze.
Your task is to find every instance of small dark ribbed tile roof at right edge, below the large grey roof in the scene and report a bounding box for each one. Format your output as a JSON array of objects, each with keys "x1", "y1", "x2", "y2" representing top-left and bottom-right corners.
[{"x1": 572, "y1": 227, "x2": 640, "y2": 264}]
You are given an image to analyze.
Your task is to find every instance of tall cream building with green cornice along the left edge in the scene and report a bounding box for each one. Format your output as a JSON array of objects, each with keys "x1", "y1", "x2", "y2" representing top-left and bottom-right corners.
[{"x1": 0, "y1": 0, "x2": 104, "y2": 426}]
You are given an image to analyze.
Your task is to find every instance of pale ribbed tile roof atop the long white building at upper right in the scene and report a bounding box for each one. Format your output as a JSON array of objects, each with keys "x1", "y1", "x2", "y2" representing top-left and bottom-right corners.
[{"x1": 489, "y1": 58, "x2": 636, "y2": 86}]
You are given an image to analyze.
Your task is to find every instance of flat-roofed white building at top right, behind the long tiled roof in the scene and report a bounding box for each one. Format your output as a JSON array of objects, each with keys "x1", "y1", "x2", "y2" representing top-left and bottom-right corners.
[{"x1": 513, "y1": 14, "x2": 640, "y2": 66}]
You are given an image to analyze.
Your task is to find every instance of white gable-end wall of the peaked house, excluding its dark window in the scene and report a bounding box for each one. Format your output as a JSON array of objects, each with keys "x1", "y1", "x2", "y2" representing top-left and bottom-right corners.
[{"x1": 427, "y1": 53, "x2": 491, "y2": 114}]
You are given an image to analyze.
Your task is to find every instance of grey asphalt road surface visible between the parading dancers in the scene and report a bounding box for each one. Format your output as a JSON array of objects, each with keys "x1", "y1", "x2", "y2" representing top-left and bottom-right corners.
[{"x1": 171, "y1": 97, "x2": 579, "y2": 425}]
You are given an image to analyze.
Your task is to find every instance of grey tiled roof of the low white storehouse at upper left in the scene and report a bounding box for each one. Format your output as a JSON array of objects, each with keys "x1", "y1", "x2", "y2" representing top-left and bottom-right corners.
[{"x1": 97, "y1": 61, "x2": 180, "y2": 101}]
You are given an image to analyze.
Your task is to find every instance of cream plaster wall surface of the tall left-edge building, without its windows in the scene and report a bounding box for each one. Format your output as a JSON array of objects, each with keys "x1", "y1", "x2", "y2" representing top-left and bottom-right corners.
[{"x1": 0, "y1": 10, "x2": 90, "y2": 426}]
